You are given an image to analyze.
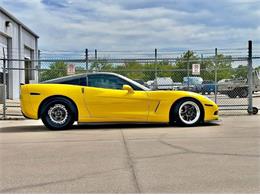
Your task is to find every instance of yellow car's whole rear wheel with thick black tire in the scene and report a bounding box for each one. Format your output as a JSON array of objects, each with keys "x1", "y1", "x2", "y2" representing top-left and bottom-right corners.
[{"x1": 40, "y1": 97, "x2": 76, "y2": 130}]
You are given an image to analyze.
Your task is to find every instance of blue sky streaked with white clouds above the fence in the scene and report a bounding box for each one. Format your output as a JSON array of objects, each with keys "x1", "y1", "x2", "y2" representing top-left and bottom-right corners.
[{"x1": 0, "y1": 0, "x2": 260, "y2": 50}]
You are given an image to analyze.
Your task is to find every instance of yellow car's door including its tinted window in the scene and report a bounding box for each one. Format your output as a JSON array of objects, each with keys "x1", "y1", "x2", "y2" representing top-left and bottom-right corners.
[{"x1": 84, "y1": 74, "x2": 148, "y2": 121}]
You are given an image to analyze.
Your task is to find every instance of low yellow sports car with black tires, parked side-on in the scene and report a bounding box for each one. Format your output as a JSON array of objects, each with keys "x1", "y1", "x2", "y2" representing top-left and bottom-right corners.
[{"x1": 21, "y1": 73, "x2": 218, "y2": 130}]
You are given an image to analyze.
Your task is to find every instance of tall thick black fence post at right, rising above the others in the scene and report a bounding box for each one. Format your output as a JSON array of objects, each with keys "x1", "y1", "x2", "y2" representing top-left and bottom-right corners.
[{"x1": 248, "y1": 40, "x2": 253, "y2": 114}]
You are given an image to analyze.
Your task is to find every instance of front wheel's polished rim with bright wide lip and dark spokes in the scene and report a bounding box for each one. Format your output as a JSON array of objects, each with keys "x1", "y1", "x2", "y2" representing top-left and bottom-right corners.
[{"x1": 179, "y1": 101, "x2": 200, "y2": 125}]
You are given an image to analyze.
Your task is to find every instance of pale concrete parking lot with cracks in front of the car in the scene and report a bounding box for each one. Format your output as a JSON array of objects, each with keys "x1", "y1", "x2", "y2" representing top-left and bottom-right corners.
[{"x1": 0, "y1": 115, "x2": 260, "y2": 193}]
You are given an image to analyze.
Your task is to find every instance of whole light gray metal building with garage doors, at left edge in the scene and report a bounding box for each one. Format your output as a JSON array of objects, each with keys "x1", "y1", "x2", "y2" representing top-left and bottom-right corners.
[{"x1": 0, "y1": 7, "x2": 39, "y2": 99}]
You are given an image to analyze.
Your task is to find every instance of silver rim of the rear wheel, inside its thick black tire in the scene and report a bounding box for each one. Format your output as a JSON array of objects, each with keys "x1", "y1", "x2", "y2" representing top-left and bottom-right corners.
[{"x1": 48, "y1": 104, "x2": 68, "y2": 124}]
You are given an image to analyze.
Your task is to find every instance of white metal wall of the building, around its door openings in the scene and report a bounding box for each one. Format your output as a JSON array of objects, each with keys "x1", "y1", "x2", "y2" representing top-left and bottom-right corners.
[{"x1": 0, "y1": 10, "x2": 38, "y2": 99}]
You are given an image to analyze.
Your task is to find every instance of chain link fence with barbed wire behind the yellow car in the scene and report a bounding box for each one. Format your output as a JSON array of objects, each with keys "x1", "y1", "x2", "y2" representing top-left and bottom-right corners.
[{"x1": 0, "y1": 43, "x2": 260, "y2": 117}]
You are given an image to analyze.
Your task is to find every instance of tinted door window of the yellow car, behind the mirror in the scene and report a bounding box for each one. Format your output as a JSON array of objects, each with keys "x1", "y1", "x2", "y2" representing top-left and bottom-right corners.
[{"x1": 88, "y1": 75, "x2": 140, "y2": 90}]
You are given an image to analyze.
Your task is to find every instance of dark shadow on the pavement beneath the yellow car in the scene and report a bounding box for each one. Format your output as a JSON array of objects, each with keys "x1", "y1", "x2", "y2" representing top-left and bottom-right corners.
[{"x1": 0, "y1": 122, "x2": 219, "y2": 133}]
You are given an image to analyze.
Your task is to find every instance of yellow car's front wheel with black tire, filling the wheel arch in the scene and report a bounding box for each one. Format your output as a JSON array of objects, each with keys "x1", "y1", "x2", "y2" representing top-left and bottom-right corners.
[{"x1": 170, "y1": 99, "x2": 204, "y2": 126}]
